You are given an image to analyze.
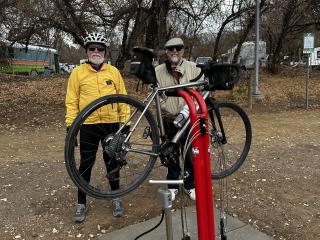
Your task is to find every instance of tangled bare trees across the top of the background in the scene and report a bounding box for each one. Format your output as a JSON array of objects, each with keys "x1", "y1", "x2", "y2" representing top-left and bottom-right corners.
[{"x1": 0, "y1": 0, "x2": 320, "y2": 71}]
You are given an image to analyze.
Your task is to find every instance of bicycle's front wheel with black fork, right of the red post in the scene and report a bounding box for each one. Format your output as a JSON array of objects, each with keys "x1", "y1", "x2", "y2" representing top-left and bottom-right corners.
[{"x1": 207, "y1": 99, "x2": 252, "y2": 179}]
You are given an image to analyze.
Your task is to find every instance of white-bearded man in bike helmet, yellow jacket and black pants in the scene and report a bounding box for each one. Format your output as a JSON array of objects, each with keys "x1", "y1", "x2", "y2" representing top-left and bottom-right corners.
[{"x1": 66, "y1": 33, "x2": 130, "y2": 222}]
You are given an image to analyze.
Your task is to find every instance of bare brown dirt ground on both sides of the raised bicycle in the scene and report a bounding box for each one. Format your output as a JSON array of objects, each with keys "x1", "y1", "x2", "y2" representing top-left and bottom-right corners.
[{"x1": 0, "y1": 110, "x2": 320, "y2": 239}]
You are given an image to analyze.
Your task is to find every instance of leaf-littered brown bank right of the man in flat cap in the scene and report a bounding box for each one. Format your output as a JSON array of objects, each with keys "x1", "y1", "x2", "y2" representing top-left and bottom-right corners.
[{"x1": 215, "y1": 67, "x2": 320, "y2": 111}]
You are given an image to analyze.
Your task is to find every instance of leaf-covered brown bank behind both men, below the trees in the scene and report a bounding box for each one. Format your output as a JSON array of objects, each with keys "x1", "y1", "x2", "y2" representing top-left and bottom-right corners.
[{"x1": 0, "y1": 68, "x2": 320, "y2": 129}]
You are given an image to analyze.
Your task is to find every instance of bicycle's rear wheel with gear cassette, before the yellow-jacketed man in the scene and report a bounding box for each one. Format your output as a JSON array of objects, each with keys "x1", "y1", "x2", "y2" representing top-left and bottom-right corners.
[{"x1": 65, "y1": 94, "x2": 159, "y2": 199}]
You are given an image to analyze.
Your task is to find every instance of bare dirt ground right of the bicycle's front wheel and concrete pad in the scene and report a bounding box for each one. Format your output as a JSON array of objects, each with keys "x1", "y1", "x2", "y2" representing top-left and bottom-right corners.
[{"x1": 222, "y1": 110, "x2": 320, "y2": 239}]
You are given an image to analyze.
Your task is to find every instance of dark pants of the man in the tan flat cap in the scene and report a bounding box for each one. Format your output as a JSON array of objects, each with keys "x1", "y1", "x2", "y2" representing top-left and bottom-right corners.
[{"x1": 163, "y1": 121, "x2": 194, "y2": 189}]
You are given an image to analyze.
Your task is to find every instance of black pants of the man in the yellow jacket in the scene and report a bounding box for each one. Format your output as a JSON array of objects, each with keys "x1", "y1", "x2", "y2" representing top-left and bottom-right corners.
[{"x1": 78, "y1": 123, "x2": 119, "y2": 204}]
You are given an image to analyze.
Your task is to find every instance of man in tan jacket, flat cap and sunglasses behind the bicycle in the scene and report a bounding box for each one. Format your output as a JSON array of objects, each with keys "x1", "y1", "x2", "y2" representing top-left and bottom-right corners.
[{"x1": 155, "y1": 38, "x2": 201, "y2": 200}]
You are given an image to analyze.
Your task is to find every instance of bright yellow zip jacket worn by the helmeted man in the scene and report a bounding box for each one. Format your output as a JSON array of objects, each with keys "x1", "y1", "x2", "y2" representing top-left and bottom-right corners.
[{"x1": 66, "y1": 63, "x2": 130, "y2": 126}]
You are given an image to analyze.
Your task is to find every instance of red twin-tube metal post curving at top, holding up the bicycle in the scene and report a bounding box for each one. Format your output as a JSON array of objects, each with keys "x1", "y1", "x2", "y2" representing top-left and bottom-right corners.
[{"x1": 178, "y1": 89, "x2": 215, "y2": 240}]
